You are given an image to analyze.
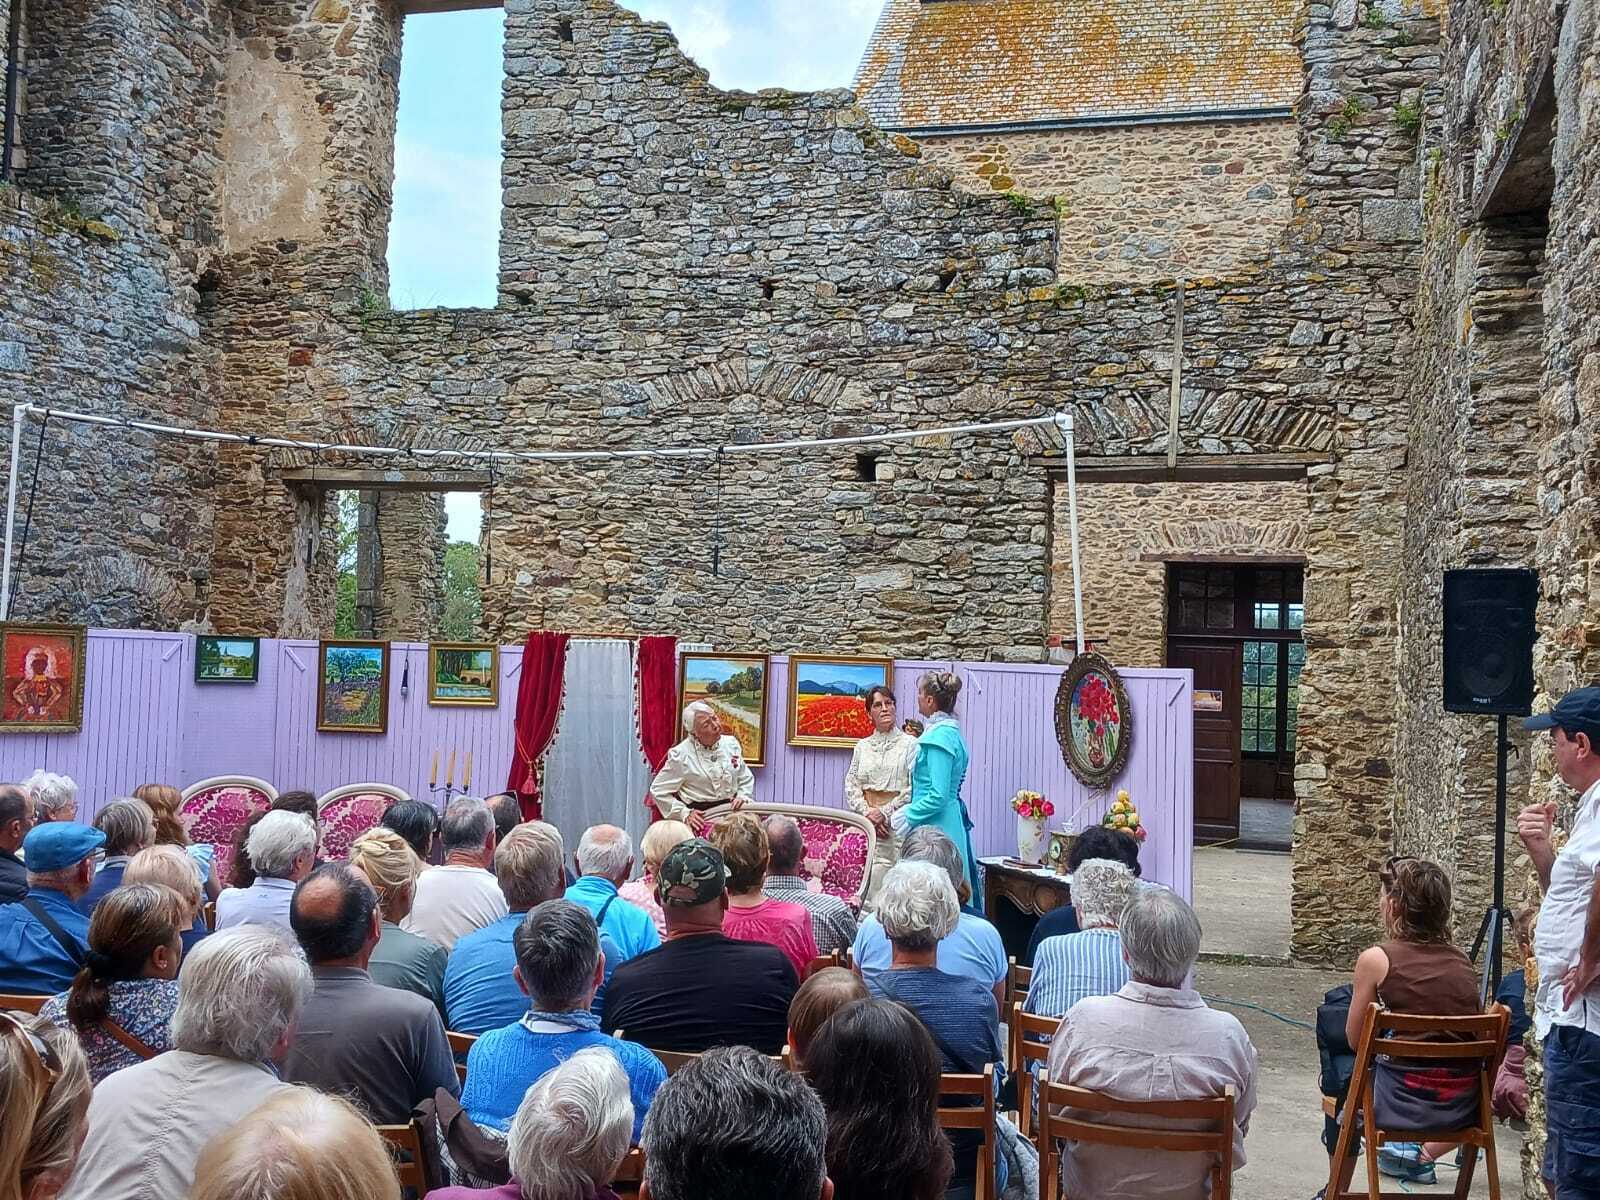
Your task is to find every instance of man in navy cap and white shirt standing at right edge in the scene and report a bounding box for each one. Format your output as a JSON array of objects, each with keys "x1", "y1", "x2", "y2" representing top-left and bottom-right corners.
[{"x1": 1517, "y1": 688, "x2": 1600, "y2": 1200}]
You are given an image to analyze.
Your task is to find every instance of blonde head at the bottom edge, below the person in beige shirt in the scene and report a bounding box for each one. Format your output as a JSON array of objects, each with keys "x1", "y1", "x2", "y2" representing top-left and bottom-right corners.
[{"x1": 189, "y1": 1088, "x2": 400, "y2": 1200}]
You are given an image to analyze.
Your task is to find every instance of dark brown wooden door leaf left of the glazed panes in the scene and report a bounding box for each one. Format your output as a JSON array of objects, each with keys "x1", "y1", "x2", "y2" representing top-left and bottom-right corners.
[{"x1": 1166, "y1": 637, "x2": 1243, "y2": 843}]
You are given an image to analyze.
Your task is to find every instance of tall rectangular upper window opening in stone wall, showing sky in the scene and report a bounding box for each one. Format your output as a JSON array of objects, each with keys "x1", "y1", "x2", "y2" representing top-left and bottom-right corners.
[{"x1": 389, "y1": 10, "x2": 506, "y2": 309}]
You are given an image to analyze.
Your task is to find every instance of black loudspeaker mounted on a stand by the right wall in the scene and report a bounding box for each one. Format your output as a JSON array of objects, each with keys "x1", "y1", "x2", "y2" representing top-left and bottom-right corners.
[{"x1": 1443, "y1": 568, "x2": 1539, "y2": 717}]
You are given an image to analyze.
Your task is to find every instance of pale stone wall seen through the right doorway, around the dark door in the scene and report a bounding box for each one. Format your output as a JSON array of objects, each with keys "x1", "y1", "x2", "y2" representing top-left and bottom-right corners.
[{"x1": 1050, "y1": 475, "x2": 1310, "y2": 667}]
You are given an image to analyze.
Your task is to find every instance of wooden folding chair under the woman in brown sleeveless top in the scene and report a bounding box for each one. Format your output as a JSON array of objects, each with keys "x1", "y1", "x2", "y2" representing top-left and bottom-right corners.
[{"x1": 1322, "y1": 1005, "x2": 1510, "y2": 1200}]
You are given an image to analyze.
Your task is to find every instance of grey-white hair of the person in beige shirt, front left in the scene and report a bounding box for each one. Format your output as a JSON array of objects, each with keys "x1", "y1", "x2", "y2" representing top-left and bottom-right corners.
[{"x1": 173, "y1": 928, "x2": 312, "y2": 1062}]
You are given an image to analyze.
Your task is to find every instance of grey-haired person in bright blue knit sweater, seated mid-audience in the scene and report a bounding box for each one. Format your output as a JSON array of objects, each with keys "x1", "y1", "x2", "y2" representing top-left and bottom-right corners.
[{"x1": 461, "y1": 899, "x2": 667, "y2": 1138}]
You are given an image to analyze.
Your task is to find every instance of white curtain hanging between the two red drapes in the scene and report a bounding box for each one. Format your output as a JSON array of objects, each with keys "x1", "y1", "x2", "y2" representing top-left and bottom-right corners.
[{"x1": 544, "y1": 638, "x2": 650, "y2": 866}]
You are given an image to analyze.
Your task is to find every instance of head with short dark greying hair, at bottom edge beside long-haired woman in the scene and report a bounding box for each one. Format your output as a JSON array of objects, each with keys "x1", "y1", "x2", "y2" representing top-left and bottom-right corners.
[{"x1": 638, "y1": 1043, "x2": 834, "y2": 1200}]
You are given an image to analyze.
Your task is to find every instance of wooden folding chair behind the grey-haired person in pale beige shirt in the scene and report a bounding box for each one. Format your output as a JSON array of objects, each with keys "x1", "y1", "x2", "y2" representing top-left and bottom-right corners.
[{"x1": 1038, "y1": 1074, "x2": 1235, "y2": 1200}]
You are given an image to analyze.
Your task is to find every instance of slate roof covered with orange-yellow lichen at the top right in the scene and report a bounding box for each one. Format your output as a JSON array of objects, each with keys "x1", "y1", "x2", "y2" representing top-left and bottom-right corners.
[{"x1": 856, "y1": 0, "x2": 1301, "y2": 128}]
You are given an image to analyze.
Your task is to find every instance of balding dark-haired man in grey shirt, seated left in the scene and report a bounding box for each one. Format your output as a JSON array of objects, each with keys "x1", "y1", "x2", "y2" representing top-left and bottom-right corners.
[{"x1": 283, "y1": 862, "x2": 461, "y2": 1125}]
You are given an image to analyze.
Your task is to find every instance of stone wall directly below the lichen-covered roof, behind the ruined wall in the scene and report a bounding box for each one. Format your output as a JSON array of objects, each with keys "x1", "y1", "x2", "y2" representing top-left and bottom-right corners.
[{"x1": 918, "y1": 118, "x2": 1296, "y2": 283}]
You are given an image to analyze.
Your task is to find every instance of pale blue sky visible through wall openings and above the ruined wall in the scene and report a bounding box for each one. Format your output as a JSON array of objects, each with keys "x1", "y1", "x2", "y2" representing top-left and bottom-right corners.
[{"x1": 389, "y1": 0, "x2": 883, "y2": 541}]
